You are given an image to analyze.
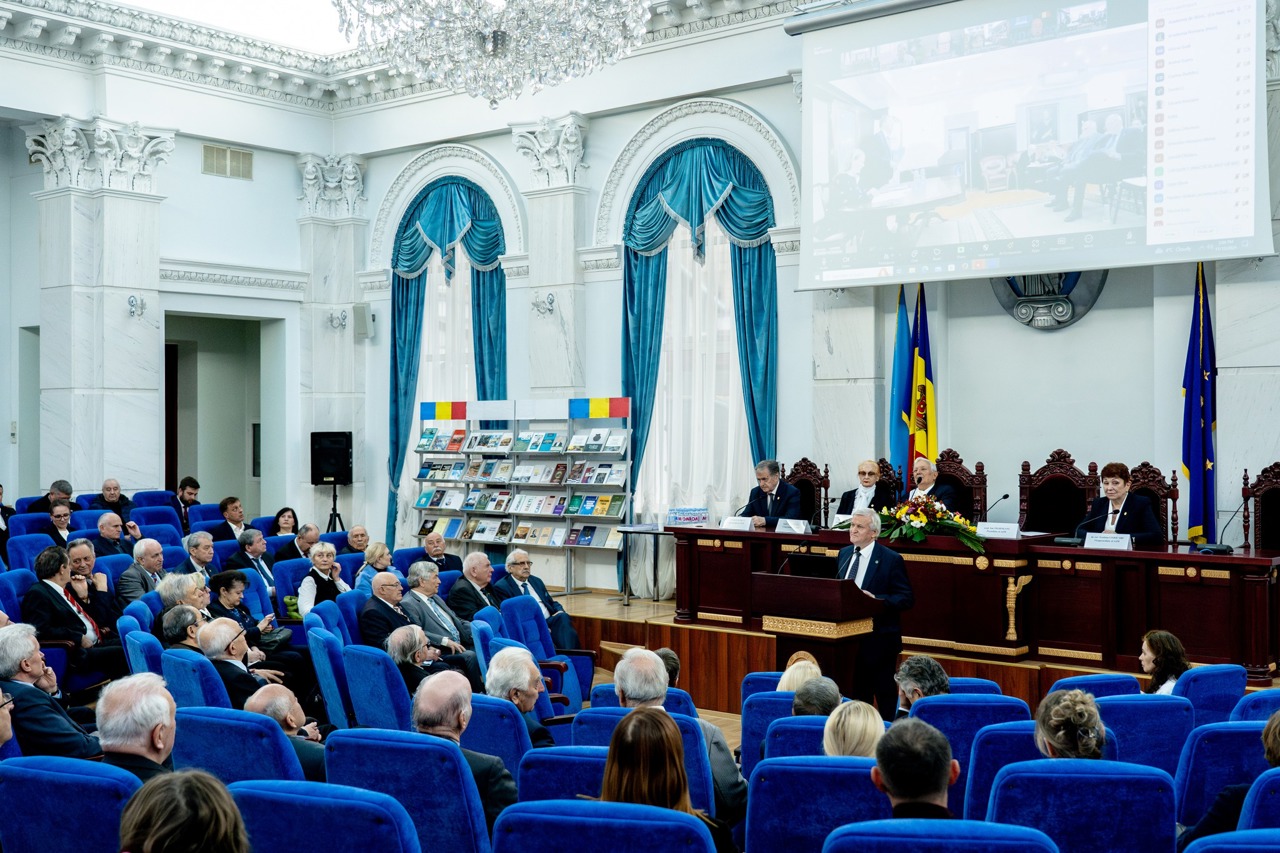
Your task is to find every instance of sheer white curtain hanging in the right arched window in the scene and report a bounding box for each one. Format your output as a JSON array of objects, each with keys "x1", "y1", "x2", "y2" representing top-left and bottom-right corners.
[{"x1": 630, "y1": 216, "x2": 751, "y2": 598}]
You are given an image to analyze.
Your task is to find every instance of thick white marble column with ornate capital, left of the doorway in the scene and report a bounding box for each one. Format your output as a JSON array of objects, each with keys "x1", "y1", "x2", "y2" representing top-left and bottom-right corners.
[{"x1": 23, "y1": 117, "x2": 174, "y2": 492}]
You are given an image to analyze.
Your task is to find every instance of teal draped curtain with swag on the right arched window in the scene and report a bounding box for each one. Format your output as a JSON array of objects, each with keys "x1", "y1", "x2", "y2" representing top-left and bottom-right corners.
[{"x1": 622, "y1": 138, "x2": 778, "y2": 473}]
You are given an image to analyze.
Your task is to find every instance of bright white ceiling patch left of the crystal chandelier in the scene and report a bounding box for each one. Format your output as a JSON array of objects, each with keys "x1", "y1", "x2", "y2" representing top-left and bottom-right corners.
[{"x1": 116, "y1": 0, "x2": 355, "y2": 54}]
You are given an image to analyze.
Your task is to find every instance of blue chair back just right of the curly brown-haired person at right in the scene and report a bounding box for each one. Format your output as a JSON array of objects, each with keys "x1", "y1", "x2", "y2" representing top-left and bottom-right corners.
[{"x1": 1097, "y1": 694, "x2": 1196, "y2": 776}]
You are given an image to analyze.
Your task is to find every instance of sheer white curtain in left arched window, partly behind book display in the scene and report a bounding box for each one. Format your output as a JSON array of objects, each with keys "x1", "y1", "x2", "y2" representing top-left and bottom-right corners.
[{"x1": 388, "y1": 246, "x2": 476, "y2": 548}]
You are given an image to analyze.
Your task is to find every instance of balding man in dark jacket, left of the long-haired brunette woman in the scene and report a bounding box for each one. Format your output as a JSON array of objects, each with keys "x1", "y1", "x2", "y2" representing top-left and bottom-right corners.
[{"x1": 413, "y1": 672, "x2": 516, "y2": 835}]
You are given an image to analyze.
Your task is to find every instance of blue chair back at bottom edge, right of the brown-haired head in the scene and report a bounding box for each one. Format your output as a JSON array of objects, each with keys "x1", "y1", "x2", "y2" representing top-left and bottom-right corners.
[{"x1": 229, "y1": 780, "x2": 422, "y2": 853}]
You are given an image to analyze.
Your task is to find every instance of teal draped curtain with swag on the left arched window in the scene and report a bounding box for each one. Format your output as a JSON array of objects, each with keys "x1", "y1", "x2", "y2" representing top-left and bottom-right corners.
[{"x1": 387, "y1": 178, "x2": 507, "y2": 542}]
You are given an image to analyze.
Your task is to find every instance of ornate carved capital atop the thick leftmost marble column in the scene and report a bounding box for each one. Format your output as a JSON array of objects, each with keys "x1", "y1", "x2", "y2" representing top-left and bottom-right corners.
[{"x1": 22, "y1": 115, "x2": 174, "y2": 193}]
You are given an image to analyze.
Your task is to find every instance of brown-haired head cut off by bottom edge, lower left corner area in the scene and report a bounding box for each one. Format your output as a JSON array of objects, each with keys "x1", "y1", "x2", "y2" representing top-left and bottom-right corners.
[{"x1": 120, "y1": 770, "x2": 249, "y2": 853}]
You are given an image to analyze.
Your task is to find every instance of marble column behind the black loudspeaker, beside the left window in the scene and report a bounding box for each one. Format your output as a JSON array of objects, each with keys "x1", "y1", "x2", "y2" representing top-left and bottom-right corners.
[{"x1": 293, "y1": 154, "x2": 366, "y2": 528}]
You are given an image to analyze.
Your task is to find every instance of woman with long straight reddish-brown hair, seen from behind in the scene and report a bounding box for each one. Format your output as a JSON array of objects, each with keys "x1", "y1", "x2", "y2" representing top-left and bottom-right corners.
[{"x1": 600, "y1": 708, "x2": 737, "y2": 853}]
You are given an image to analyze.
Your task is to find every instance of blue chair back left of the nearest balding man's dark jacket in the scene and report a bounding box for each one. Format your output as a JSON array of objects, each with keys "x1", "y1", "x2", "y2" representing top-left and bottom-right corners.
[{"x1": 325, "y1": 729, "x2": 489, "y2": 853}]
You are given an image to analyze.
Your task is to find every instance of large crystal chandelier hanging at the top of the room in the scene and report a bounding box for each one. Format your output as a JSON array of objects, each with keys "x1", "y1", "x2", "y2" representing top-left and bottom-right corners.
[{"x1": 333, "y1": 0, "x2": 649, "y2": 109}]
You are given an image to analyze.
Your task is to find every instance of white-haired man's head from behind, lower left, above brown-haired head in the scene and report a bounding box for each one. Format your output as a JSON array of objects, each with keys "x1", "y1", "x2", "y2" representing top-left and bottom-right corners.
[{"x1": 97, "y1": 672, "x2": 178, "y2": 783}]
